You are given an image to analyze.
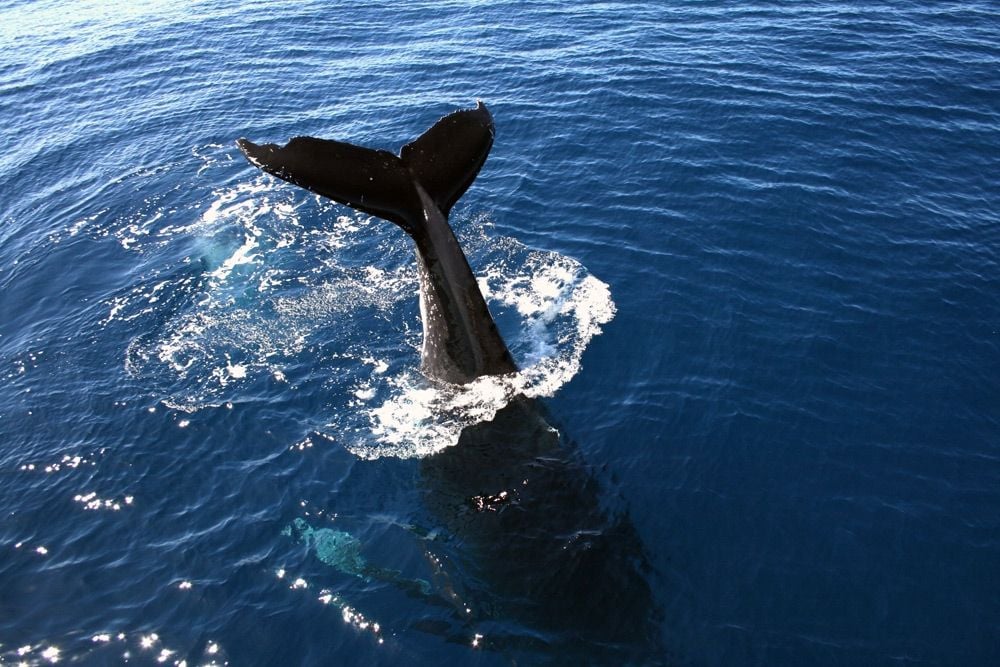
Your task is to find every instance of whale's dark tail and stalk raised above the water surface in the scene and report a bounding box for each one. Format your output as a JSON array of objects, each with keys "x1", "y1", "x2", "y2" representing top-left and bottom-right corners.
[{"x1": 236, "y1": 102, "x2": 517, "y2": 384}]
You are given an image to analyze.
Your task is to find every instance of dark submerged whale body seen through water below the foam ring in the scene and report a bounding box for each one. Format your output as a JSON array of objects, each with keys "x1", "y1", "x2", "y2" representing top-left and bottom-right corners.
[{"x1": 421, "y1": 397, "x2": 663, "y2": 664}]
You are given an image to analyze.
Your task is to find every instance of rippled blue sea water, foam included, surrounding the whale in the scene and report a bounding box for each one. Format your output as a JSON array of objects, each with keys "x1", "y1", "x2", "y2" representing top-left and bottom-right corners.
[{"x1": 0, "y1": 0, "x2": 1000, "y2": 665}]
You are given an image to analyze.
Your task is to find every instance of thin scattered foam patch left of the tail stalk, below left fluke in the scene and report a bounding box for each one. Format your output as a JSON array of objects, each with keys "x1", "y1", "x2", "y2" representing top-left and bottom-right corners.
[{"x1": 118, "y1": 184, "x2": 416, "y2": 412}]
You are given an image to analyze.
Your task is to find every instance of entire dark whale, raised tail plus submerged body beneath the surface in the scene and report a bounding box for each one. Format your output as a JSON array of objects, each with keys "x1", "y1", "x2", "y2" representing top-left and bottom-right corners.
[{"x1": 237, "y1": 102, "x2": 660, "y2": 664}]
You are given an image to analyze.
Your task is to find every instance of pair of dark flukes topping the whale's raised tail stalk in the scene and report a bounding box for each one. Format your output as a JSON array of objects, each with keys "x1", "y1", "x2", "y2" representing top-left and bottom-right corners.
[{"x1": 236, "y1": 102, "x2": 493, "y2": 236}]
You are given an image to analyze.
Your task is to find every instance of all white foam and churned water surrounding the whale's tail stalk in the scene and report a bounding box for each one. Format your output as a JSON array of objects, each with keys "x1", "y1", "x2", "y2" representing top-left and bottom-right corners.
[{"x1": 117, "y1": 176, "x2": 615, "y2": 459}]
